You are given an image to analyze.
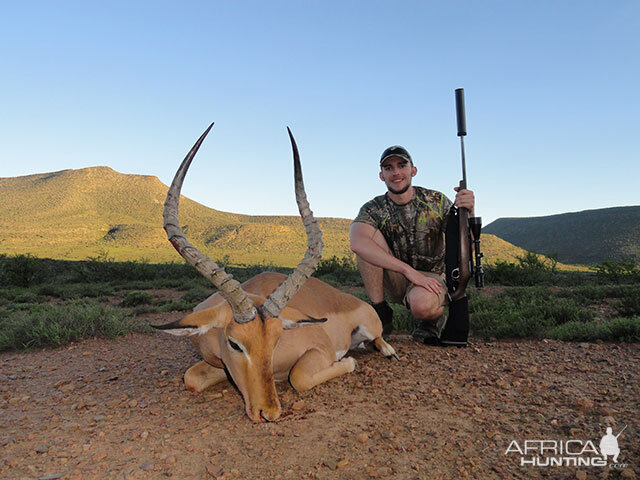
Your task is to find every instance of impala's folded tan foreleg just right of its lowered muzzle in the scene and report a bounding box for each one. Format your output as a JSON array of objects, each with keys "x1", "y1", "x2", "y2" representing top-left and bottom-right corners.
[{"x1": 289, "y1": 350, "x2": 358, "y2": 392}]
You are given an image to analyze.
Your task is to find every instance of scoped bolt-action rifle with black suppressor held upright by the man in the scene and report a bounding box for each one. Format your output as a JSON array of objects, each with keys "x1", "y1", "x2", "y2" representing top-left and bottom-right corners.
[{"x1": 440, "y1": 88, "x2": 484, "y2": 347}]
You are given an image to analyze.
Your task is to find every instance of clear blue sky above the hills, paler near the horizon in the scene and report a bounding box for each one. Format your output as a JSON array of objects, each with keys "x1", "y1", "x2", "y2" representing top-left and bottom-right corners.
[{"x1": 0, "y1": 0, "x2": 640, "y2": 225}]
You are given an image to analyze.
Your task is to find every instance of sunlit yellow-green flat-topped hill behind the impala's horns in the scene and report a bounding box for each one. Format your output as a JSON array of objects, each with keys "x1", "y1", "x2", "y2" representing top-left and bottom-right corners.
[{"x1": 0, "y1": 167, "x2": 568, "y2": 266}]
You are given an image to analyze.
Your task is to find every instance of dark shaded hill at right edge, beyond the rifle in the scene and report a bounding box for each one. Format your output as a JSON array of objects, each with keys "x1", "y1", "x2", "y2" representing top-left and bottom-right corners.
[{"x1": 482, "y1": 206, "x2": 640, "y2": 265}]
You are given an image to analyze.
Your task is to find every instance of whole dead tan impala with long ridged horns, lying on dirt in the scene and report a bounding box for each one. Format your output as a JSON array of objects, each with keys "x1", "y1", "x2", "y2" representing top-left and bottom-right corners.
[{"x1": 157, "y1": 124, "x2": 397, "y2": 421}]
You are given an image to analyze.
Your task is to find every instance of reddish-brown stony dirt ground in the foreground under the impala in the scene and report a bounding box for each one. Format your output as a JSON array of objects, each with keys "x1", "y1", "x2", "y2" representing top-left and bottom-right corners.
[{"x1": 0, "y1": 314, "x2": 640, "y2": 479}]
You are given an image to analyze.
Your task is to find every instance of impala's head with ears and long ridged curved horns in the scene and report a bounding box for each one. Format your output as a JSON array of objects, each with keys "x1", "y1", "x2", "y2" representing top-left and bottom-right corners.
[{"x1": 158, "y1": 124, "x2": 324, "y2": 421}]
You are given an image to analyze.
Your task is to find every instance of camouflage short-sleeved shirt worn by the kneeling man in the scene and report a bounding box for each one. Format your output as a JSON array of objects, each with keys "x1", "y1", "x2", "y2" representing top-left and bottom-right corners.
[{"x1": 354, "y1": 187, "x2": 453, "y2": 273}]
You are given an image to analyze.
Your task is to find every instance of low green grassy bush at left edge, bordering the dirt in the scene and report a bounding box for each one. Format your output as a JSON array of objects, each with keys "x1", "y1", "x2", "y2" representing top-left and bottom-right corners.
[{"x1": 0, "y1": 300, "x2": 148, "y2": 351}]
